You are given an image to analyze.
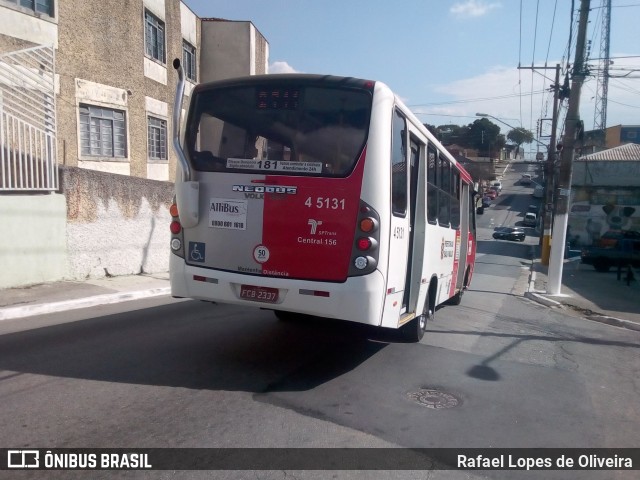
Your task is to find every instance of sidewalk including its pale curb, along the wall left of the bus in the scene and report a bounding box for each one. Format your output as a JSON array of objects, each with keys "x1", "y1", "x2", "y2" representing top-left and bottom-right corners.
[{"x1": 0, "y1": 273, "x2": 170, "y2": 321}]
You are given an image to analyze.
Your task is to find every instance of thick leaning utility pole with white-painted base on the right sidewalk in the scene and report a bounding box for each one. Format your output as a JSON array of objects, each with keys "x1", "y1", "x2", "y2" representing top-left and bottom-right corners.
[{"x1": 547, "y1": 0, "x2": 590, "y2": 295}]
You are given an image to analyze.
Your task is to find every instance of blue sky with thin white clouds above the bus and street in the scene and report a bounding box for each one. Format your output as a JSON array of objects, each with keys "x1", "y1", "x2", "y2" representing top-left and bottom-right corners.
[{"x1": 183, "y1": 0, "x2": 640, "y2": 158}]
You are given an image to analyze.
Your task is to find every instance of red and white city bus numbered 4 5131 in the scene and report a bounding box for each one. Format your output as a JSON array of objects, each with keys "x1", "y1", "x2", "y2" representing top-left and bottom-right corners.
[{"x1": 170, "y1": 62, "x2": 476, "y2": 341}]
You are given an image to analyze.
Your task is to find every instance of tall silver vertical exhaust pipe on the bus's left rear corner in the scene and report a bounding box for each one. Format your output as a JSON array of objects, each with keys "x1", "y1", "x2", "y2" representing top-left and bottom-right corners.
[{"x1": 173, "y1": 58, "x2": 200, "y2": 228}]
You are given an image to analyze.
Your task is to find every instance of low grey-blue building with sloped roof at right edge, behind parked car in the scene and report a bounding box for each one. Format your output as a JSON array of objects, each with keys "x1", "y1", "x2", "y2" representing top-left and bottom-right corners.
[{"x1": 567, "y1": 143, "x2": 640, "y2": 246}]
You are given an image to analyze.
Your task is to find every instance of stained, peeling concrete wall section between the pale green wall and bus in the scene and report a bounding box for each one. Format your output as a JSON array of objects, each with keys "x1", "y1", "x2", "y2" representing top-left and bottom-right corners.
[{"x1": 61, "y1": 168, "x2": 173, "y2": 280}]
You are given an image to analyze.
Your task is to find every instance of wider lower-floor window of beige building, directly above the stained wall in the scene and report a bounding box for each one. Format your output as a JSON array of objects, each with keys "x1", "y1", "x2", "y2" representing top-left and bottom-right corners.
[{"x1": 80, "y1": 105, "x2": 127, "y2": 158}]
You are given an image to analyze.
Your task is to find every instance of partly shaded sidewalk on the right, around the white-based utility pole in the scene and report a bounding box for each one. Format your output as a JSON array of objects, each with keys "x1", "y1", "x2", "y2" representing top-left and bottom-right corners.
[{"x1": 525, "y1": 257, "x2": 640, "y2": 331}]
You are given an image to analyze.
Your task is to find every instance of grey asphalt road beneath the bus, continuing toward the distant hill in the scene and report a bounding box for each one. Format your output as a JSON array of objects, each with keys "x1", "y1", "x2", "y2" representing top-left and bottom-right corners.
[{"x1": 0, "y1": 163, "x2": 640, "y2": 479}]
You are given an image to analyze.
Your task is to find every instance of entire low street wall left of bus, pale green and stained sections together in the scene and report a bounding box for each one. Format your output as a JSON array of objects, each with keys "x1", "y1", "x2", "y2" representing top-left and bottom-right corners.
[{"x1": 0, "y1": 167, "x2": 174, "y2": 288}]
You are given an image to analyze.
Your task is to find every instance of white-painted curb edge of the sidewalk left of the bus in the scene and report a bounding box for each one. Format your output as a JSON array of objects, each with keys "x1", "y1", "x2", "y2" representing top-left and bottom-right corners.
[{"x1": 0, "y1": 287, "x2": 171, "y2": 321}]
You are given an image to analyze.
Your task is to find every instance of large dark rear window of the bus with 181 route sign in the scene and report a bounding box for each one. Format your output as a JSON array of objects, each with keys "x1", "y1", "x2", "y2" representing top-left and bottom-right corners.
[{"x1": 186, "y1": 84, "x2": 371, "y2": 177}]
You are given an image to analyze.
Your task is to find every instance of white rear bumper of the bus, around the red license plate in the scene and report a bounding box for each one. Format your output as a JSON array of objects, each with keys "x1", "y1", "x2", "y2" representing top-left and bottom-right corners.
[{"x1": 170, "y1": 254, "x2": 384, "y2": 326}]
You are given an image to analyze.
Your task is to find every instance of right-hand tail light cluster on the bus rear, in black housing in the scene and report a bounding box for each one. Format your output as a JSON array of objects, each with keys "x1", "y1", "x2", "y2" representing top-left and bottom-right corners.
[{"x1": 349, "y1": 200, "x2": 380, "y2": 277}]
